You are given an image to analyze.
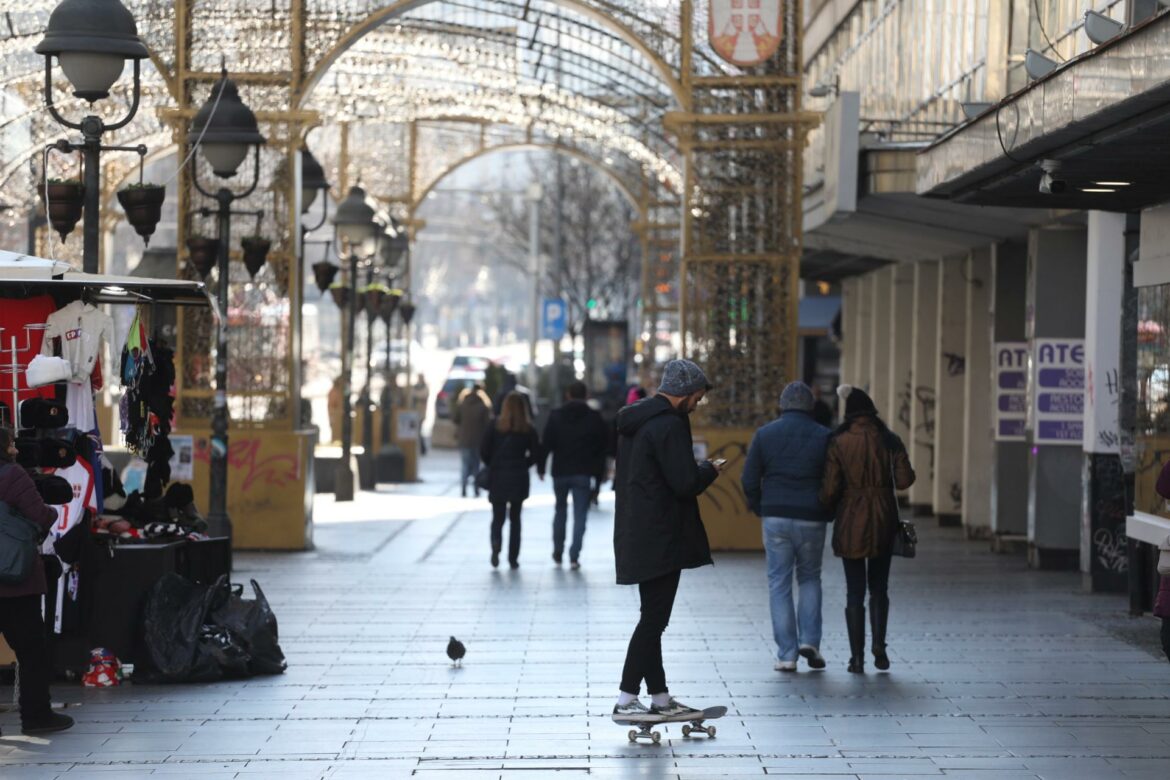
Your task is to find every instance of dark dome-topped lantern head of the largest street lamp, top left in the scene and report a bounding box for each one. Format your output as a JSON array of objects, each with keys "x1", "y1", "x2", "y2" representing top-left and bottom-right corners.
[{"x1": 36, "y1": 0, "x2": 149, "y2": 103}]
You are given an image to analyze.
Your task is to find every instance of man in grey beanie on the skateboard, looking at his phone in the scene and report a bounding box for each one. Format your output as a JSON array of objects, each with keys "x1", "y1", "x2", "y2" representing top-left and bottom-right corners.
[{"x1": 613, "y1": 360, "x2": 725, "y2": 717}]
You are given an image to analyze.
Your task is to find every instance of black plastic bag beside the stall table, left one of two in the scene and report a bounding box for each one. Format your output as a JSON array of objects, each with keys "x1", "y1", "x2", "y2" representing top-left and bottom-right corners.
[{"x1": 135, "y1": 572, "x2": 223, "y2": 683}]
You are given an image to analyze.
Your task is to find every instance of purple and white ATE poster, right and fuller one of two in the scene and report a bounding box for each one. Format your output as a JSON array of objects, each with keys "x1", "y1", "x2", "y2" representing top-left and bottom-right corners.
[{"x1": 1032, "y1": 339, "x2": 1085, "y2": 447}]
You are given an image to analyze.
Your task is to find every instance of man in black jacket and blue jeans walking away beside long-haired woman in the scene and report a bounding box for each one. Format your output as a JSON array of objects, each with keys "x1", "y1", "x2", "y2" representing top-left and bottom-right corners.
[{"x1": 541, "y1": 380, "x2": 608, "y2": 570}]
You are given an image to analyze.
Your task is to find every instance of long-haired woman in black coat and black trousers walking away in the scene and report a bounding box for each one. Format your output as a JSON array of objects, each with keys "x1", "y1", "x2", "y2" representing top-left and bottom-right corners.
[{"x1": 480, "y1": 392, "x2": 544, "y2": 568}]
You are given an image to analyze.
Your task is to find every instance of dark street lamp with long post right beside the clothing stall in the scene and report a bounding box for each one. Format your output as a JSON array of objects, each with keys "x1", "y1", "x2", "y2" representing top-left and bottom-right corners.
[{"x1": 188, "y1": 69, "x2": 264, "y2": 537}]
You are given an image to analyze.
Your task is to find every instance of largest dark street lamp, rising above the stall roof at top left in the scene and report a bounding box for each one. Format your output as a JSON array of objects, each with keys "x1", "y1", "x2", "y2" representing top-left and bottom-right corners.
[{"x1": 36, "y1": 0, "x2": 149, "y2": 274}]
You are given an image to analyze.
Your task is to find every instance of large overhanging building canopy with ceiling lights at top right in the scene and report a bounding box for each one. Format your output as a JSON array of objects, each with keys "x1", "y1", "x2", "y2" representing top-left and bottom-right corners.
[{"x1": 916, "y1": 13, "x2": 1170, "y2": 212}]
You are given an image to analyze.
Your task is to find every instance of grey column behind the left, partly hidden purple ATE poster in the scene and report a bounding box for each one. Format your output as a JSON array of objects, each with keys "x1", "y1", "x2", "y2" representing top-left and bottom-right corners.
[{"x1": 991, "y1": 243, "x2": 1028, "y2": 542}]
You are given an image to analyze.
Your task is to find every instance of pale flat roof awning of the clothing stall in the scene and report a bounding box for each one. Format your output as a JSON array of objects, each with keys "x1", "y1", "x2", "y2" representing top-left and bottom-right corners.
[{"x1": 0, "y1": 249, "x2": 219, "y2": 319}]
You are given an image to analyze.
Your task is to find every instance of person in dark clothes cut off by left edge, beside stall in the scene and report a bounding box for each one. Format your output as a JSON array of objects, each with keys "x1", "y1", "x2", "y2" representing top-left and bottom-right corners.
[{"x1": 0, "y1": 428, "x2": 73, "y2": 734}]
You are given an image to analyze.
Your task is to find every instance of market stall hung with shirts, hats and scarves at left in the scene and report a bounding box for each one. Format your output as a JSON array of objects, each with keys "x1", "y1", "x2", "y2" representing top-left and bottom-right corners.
[{"x1": 0, "y1": 250, "x2": 230, "y2": 671}]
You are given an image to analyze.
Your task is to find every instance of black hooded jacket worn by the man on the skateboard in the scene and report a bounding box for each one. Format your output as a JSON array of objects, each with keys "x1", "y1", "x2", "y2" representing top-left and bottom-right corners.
[{"x1": 613, "y1": 395, "x2": 718, "y2": 585}]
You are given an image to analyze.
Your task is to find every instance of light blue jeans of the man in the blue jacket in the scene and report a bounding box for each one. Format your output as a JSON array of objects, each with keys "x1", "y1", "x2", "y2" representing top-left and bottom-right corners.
[{"x1": 763, "y1": 517, "x2": 828, "y2": 661}]
